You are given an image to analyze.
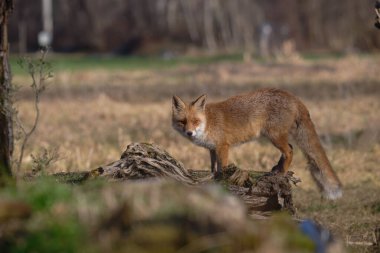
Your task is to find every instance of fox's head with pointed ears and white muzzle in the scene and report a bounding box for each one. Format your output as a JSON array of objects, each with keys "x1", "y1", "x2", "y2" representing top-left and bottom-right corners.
[{"x1": 172, "y1": 95, "x2": 206, "y2": 139}]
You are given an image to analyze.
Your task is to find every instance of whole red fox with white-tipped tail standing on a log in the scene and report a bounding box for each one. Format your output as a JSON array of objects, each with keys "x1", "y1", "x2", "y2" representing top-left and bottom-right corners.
[{"x1": 172, "y1": 89, "x2": 342, "y2": 199}]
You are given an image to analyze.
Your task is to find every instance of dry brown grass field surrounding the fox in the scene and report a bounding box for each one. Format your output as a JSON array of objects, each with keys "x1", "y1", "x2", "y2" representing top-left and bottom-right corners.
[{"x1": 14, "y1": 56, "x2": 380, "y2": 252}]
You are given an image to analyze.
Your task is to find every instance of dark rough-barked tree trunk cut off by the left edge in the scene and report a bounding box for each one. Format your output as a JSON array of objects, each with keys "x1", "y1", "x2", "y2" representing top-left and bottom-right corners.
[{"x1": 0, "y1": 0, "x2": 13, "y2": 181}]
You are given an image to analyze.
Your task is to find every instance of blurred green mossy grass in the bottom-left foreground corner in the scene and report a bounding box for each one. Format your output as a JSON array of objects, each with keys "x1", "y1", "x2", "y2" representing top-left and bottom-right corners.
[{"x1": 0, "y1": 177, "x2": 94, "y2": 253}]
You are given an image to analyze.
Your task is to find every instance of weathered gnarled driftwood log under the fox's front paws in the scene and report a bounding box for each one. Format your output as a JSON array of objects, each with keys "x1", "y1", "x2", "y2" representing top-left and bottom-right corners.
[{"x1": 90, "y1": 143, "x2": 298, "y2": 214}]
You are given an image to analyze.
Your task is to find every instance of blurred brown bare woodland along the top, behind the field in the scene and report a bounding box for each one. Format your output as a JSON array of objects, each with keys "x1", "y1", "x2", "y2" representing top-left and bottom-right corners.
[{"x1": 10, "y1": 0, "x2": 380, "y2": 57}]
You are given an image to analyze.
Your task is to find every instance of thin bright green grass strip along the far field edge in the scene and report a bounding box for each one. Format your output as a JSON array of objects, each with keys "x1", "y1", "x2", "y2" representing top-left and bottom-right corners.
[{"x1": 10, "y1": 52, "x2": 380, "y2": 75}]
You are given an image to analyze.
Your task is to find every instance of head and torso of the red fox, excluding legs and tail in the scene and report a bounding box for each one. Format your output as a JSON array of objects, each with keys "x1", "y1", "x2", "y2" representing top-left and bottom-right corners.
[{"x1": 172, "y1": 89, "x2": 299, "y2": 148}]
